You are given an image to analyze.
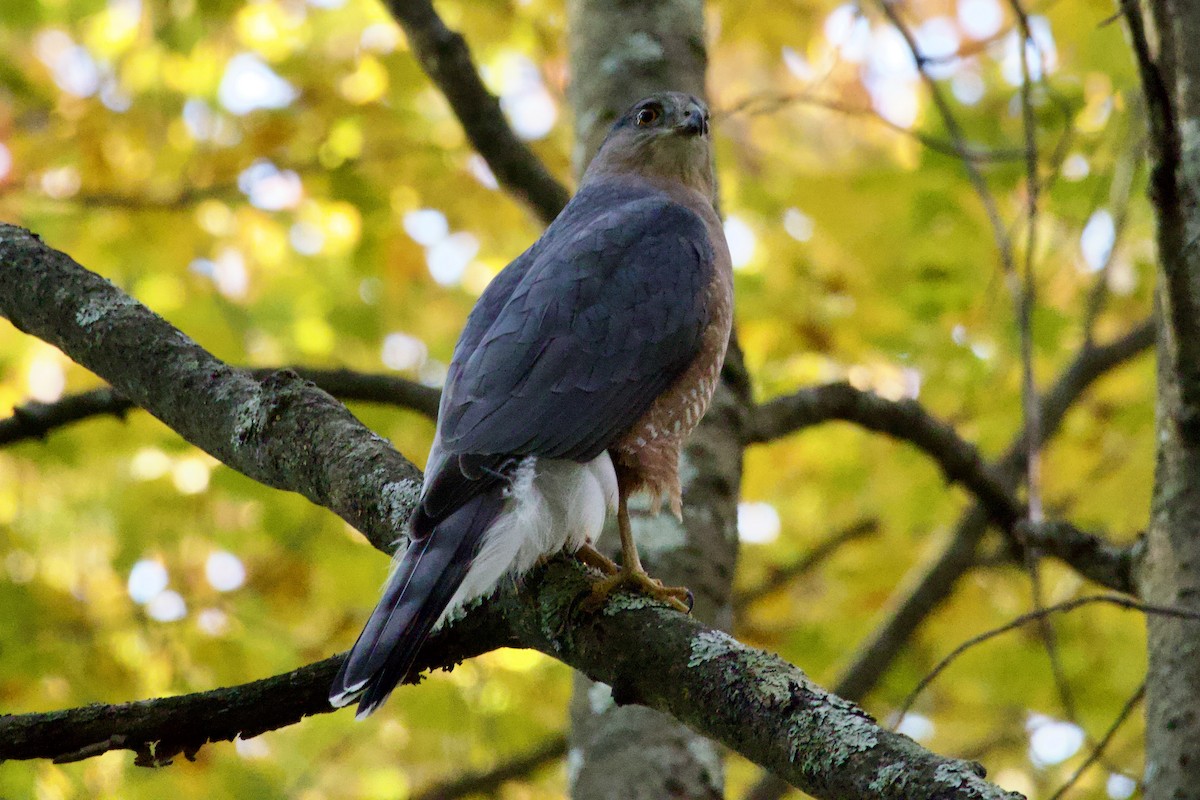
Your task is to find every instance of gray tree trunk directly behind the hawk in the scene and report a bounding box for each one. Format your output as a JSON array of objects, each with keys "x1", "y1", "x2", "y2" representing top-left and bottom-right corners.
[{"x1": 568, "y1": 0, "x2": 749, "y2": 800}]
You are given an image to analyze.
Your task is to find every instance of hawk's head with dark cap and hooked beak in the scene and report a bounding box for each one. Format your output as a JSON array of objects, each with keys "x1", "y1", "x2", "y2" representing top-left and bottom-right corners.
[{"x1": 583, "y1": 91, "x2": 716, "y2": 199}]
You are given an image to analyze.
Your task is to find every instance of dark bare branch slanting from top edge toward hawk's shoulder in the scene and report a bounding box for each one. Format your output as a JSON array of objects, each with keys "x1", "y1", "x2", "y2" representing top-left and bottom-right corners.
[{"x1": 386, "y1": 0, "x2": 570, "y2": 224}]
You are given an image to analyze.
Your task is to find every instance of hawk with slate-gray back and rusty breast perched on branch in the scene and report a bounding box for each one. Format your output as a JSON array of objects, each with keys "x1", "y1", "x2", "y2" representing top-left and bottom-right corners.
[{"x1": 330, "y1": 92, "x2": 733, "y2": 717}]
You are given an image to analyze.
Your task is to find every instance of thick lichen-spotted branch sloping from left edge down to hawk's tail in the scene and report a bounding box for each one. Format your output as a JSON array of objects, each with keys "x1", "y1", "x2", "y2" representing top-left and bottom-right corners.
[{"x1": 0, "y1": 224, "x2": 420, "y2": 547}]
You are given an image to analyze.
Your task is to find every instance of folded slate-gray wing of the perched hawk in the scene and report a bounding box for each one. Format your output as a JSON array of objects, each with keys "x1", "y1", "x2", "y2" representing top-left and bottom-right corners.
[{"x1": 438, "y1": 190, "x2": 714, "y2": 462}]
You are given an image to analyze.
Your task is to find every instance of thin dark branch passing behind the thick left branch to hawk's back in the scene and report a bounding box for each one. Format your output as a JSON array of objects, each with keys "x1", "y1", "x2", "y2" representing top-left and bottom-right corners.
[{"x1": 0, "y1": 367, "x2": 442, "y2": 446}]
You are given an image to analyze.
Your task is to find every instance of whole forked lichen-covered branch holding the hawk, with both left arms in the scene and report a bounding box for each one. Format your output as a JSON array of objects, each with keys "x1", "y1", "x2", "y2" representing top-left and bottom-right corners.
[{"x1": 0, "y1": 225, "x2": 1032, "y2": 799}]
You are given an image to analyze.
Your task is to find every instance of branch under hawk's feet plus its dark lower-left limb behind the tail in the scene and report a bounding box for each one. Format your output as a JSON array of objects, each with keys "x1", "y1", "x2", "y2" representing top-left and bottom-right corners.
[{"x1": 0, "y1": 558, "x2": 1020, "y2": 800}]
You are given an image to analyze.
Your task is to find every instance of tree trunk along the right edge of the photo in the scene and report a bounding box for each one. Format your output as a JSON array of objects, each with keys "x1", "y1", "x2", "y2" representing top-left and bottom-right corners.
[{"x1": 1129, "y1": 0, "x2": 1200, "y2": 800}]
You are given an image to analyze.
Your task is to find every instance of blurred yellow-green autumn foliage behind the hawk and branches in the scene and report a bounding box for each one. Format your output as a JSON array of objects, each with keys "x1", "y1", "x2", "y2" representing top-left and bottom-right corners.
[{"x1": 0, "y1": 0, "x2": 1153, "y2": 800}]
